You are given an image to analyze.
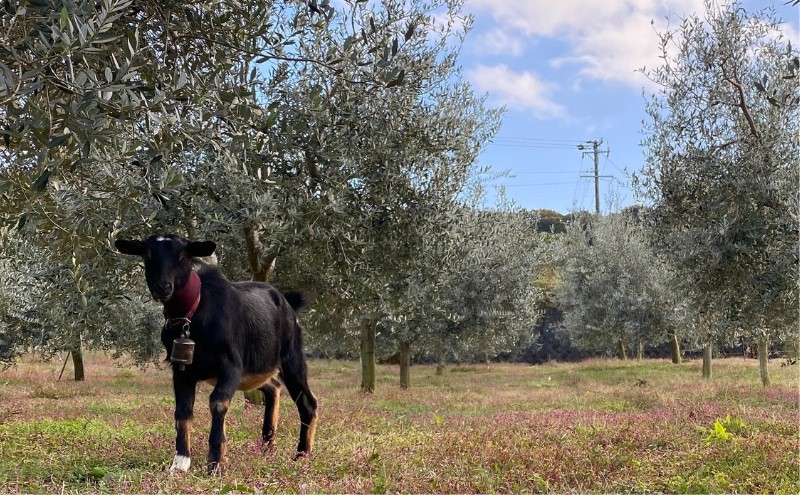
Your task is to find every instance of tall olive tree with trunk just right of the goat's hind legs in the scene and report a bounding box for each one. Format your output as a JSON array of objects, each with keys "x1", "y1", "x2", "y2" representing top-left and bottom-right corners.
[{"x1": 262, "y1": 0, "x2": 500, "y2": 391}]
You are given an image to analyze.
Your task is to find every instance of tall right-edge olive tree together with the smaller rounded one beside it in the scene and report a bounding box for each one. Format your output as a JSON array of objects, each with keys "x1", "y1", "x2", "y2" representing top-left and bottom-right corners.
[{"x1": 559, "y1": 2, "x2": 800, "y2": 385}]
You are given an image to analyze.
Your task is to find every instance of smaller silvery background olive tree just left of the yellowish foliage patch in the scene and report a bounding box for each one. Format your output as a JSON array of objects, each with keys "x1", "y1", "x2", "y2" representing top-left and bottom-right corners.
[{"x1": 434, "y1": 204, "x2": 541, "y2": 362}]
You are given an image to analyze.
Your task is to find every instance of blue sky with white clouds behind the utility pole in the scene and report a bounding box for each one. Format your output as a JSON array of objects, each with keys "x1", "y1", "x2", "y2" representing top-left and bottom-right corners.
[{"x1": 460, "y1": 0, "x2": 800, "y2": 213}]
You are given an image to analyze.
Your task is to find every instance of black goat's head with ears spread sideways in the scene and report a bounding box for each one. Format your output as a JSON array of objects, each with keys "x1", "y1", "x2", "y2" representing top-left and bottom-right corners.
[{"x1": 114, "y1": 234, "x2": 217, "y2": 302}]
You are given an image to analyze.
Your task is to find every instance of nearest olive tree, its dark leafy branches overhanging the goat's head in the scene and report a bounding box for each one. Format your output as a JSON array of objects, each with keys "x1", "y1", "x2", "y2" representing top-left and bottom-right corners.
[{"x1": 0, "y1": 0, "x2": 424, "y2": 372}]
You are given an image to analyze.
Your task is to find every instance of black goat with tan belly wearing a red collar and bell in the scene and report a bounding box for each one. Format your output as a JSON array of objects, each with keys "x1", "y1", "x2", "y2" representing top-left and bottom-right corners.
[{"x1": 114, "y1": 234, "x2": 317, "y2": 473}]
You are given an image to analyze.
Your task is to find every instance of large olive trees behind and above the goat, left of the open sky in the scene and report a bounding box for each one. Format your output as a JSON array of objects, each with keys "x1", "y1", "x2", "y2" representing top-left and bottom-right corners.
[{"x1": 0, "y1": 0, "x2": 536, "y2": 389}]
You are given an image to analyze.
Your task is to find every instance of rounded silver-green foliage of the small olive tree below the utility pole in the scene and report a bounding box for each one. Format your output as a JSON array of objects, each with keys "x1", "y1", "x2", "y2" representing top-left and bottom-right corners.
[{"x1": 555, "y1": 214, "x2": 685, "y2": 354}]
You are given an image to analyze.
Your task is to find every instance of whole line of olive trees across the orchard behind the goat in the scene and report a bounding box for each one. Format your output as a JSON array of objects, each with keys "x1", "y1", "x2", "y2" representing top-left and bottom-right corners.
[{"x1": 0, "y1": 0, "x2": 798, "y2": 391}]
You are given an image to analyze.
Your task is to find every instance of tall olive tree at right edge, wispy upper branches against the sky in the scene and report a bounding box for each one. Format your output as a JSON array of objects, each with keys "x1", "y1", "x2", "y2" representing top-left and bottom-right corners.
[{"x1": 638, "y1": 2, "x2": 800, "y2": 385}]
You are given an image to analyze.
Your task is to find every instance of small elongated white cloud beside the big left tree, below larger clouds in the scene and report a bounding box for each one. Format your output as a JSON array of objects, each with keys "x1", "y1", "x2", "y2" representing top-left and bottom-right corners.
[{"x1": 467, "y1": 65, "x2": 565, "y2": 120}]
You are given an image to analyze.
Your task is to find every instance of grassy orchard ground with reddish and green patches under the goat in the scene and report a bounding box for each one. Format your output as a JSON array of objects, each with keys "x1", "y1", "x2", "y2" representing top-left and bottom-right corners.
[{"x1": 0, "y1": 354, "x2": 800, "y2": 493}]
